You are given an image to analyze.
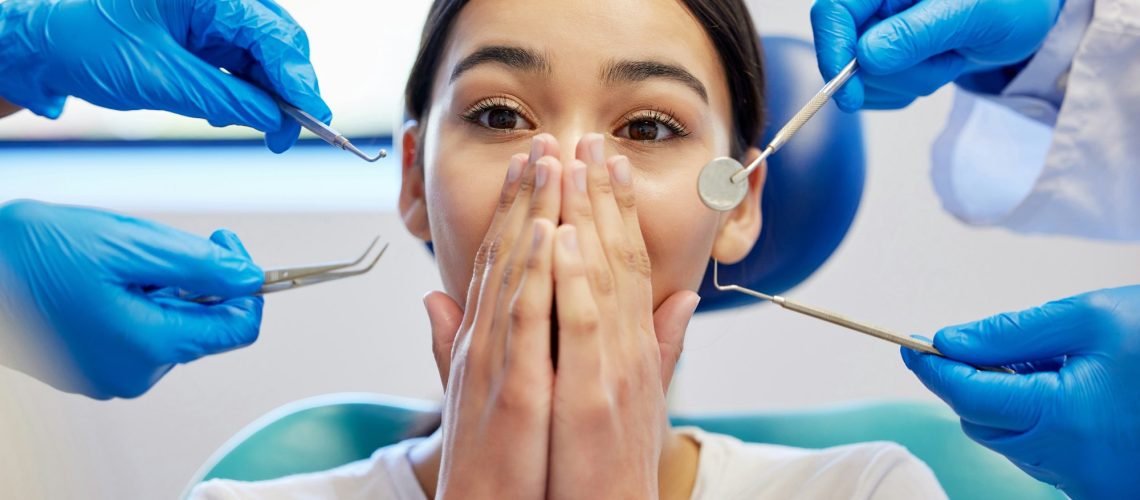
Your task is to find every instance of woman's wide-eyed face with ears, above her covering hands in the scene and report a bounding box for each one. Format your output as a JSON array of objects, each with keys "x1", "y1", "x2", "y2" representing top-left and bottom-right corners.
[{"x1": 401, "y1": 0, "x2": 763, "y2": 309}]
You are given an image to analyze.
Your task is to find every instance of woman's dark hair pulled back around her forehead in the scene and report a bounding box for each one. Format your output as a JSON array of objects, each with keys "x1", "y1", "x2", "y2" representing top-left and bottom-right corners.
[{"x1": 404, "y1": 0, "x2": 766, "y2": 158}]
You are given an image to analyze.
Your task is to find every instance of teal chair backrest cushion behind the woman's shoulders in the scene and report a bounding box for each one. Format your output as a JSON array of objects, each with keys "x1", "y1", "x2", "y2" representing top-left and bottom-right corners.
[{"x1": 187, "y1": 394, "x2": 1065, "y2": 500}]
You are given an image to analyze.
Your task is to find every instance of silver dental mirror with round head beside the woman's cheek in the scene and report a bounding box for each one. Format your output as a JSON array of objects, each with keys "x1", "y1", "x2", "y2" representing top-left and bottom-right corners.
[{"x1": 697, "y1": 60, "x2": 858, "y2": 212}]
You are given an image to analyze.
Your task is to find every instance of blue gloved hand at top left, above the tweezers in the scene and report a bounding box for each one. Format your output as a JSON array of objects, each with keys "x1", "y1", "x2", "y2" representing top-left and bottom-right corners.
[{"x1": 0, "y1": 0, "x2": 332, "y2": 153}]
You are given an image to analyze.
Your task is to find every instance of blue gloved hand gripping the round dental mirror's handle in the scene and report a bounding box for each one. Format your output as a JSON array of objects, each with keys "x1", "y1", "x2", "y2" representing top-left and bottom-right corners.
[{"x1": 812, "y1": 0, "x2": 1065, "y2": 112}]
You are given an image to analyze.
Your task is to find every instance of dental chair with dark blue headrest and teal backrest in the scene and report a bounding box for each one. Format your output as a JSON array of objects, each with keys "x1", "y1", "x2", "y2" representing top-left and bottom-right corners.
[{"x1": 187, "y1": 36, "x2": 1065, "y2": 500}]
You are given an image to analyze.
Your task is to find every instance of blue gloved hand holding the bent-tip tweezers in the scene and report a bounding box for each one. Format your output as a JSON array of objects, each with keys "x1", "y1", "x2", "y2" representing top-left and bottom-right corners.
[{"x1": 0, "y1": 200, "x2": 264, "y2": 399}]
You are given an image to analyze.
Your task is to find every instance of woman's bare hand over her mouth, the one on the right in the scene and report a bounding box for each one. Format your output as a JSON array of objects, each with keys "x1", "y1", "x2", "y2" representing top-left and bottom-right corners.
[{"x1": 547, "y1": 134, "x2": 700, "y2": 499}]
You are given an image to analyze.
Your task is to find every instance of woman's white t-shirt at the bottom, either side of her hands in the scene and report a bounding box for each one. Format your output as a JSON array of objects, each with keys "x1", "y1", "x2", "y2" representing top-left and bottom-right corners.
[{"x1": 189, "y1": 427, "x2": 946, "y2": 500}]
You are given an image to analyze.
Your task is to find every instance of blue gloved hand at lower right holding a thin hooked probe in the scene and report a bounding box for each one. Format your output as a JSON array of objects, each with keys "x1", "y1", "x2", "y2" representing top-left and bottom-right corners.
[{"x1": 903, "y1": 286, "x2": 1140, "y2": 499}]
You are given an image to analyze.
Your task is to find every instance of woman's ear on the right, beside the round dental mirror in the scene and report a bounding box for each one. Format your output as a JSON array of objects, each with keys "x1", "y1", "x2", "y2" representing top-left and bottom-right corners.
[{"x1": 713, "y1": 148, "x2": 768, "y2": 264}]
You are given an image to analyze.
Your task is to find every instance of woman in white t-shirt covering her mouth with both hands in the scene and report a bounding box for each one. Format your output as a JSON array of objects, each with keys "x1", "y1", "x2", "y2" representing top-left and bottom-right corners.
[{"x1": 196, "y1": 0, "x2": 944, "y2": 499}]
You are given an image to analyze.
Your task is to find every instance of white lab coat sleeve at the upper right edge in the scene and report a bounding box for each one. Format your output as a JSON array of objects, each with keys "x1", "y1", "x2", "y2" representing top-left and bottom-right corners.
[{"x1": 931, "y1": 0, "x2": 1140, "y2": 240}]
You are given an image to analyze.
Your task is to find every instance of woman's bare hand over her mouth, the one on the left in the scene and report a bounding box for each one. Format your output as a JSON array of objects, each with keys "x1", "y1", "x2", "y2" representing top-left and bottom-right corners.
[{"x1": 424, "y1": 134, "x2": 562, "y2": 499}]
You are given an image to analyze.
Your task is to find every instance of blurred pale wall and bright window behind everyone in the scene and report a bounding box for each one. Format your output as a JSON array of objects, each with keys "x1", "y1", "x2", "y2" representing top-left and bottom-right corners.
[{"x1": 0, "y1": 0, "x2": 1140, "y2": 499}]
